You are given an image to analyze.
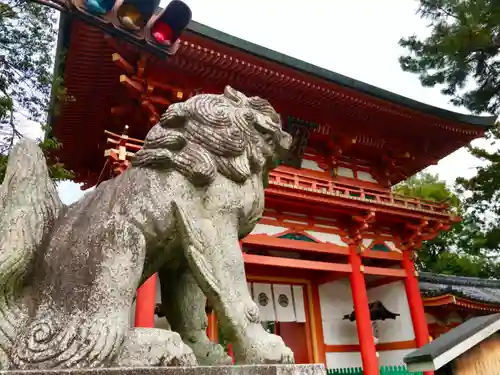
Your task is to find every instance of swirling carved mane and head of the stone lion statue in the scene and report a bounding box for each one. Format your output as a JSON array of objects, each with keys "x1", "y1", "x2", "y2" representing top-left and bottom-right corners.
[{"x1": 133, "y1": 86, "x2": 281, "y2": 186}]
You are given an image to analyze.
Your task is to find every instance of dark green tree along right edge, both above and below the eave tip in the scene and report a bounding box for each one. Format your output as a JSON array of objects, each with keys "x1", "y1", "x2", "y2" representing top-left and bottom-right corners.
[{"x1": 399, "y1": 0, "x2": 500, "y2": 277}]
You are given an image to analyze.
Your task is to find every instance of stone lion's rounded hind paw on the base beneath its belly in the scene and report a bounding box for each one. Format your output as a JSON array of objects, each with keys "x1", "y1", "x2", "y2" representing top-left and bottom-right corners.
[{"x1": 115, "y1": 328, "x2": 198, "y2": 367}]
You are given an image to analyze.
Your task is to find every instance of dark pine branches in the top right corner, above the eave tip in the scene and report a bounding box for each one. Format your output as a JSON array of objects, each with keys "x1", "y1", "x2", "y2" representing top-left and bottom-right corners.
[{"x1": 399, "y1": 0, "x2": 500, "y2": 113}]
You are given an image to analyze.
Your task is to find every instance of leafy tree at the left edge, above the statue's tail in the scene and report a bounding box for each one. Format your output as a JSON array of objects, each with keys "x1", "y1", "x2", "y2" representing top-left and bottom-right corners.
[{"x1": 0, "y1": 0, "x2": 72, "y2": 181}]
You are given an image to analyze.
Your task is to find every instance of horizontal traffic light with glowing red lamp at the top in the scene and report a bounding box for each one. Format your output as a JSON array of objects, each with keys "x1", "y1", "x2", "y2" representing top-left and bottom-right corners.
[{"x1": 71, "y1": 0, "x2": 192, "y2": 54}]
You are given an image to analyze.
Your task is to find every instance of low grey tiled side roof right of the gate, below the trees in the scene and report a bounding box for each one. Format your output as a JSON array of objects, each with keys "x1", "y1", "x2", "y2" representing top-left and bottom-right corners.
[{"x1": 419, "y1": 272, "x2": 500, "y2": 305}]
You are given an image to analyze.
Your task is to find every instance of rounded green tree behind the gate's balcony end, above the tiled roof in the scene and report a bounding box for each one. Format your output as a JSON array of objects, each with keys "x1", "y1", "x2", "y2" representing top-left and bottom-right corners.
[{"x1": 394, "y1": 173, "x2": 497, "y2": 277}]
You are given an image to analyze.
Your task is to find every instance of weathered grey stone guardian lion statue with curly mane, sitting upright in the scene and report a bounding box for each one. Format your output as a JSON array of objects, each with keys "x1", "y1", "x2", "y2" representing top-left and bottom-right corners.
[{"x1": 0, "y1": 87, "x2": 293, "y2": 369}]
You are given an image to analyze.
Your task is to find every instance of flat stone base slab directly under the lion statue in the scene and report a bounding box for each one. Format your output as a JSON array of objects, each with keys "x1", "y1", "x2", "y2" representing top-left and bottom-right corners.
[{"x1": 0, "y1": 364, "x2": 326, "y2": 375}]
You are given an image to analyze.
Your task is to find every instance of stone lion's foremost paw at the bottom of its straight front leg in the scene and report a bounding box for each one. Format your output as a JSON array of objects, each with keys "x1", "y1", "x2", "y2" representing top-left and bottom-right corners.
[{"x1": 234, "y1": 324, "x2": 295, "y2": 364}]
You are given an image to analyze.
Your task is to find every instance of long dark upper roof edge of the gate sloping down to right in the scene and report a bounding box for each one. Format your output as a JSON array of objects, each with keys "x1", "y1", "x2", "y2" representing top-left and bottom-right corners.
[{"x1": 188, "y1": 21, "x2": 496, "y2": 129}]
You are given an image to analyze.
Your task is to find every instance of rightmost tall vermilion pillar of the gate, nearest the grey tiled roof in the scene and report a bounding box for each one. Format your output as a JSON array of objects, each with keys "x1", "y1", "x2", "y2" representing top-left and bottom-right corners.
[{"x1": 403, "y1": 250, "x2": 434, "y2": 375}]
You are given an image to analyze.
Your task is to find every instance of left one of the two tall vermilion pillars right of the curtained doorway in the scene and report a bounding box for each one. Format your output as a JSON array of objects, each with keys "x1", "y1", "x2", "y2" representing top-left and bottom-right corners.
[{"x1": 349, "y1": 245, "x2": 380, "y2": 375}]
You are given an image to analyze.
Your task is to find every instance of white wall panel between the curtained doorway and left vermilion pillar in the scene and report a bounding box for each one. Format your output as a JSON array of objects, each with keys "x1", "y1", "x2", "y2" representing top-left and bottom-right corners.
[{"x1": 318, "y1": 278, "x2": 359, "y2": 345}]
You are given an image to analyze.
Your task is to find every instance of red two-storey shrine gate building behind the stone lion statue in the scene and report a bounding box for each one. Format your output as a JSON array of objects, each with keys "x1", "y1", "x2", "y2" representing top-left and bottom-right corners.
[{"x1": 46, "y1": 0, "x2": 500, "y2": 375}]
